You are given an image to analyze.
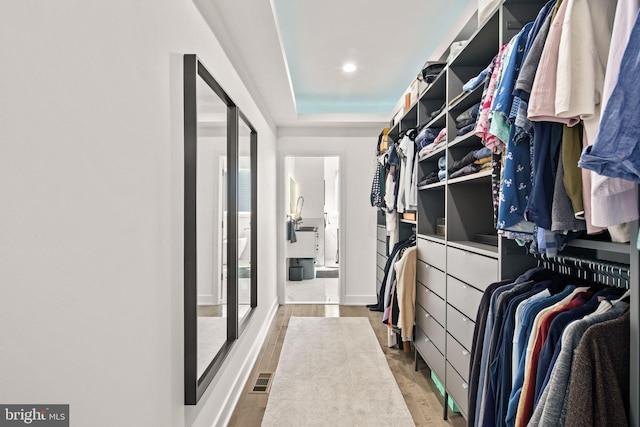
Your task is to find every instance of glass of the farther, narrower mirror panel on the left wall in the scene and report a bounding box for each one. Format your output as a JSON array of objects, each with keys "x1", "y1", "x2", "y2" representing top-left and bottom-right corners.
[{"x1": 237, "y1": 117, "x2": 254, "y2": 323}]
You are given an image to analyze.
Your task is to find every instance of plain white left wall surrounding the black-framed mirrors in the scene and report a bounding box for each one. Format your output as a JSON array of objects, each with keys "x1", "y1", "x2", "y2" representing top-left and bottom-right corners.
[{"x1": 0, "y1": 0, "x2": 276, "y2": 427}]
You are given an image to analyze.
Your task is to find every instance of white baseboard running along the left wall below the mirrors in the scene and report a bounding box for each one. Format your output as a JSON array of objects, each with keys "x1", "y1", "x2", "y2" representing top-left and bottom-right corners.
[{"x1": 213, "y1": 298, "x2": 278, "y2": 426}]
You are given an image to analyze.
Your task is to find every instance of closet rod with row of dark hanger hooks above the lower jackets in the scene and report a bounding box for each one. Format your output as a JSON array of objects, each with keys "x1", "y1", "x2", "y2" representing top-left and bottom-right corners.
[{"x1": 534, "y1": 253, "x2": 630, "y2": 289}]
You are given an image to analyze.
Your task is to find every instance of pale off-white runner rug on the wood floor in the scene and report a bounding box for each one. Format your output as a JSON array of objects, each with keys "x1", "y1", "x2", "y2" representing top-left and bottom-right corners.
[{"x1": 262, "y1": 317, "x2": 415, "y2": 427}]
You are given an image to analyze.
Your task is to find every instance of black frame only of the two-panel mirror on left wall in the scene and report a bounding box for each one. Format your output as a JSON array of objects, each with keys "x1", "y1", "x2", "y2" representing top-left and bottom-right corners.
[{"x1": 183, "y1": 54, "x2": 258, "y2": 405}]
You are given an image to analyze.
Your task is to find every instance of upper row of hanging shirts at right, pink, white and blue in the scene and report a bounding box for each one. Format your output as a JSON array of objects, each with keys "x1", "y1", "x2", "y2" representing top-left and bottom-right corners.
[{"x1": 476, "y1": 0, "x2": 640, "y2": 251}]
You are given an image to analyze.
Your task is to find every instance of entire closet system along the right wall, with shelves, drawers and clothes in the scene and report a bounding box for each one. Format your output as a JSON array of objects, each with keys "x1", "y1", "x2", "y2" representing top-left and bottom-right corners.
[{"x1": 371, "y1": 0, "x2": 640, "y2": 427}]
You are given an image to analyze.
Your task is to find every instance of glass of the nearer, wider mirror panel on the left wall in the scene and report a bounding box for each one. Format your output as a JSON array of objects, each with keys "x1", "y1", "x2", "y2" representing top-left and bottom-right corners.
[{"x1": 196, "y1": 76, "x2": 227, "y2": 378}]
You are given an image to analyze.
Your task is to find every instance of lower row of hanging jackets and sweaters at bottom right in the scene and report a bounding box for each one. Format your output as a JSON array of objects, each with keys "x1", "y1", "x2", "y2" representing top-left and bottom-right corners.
[{"x1": 468, "y1": 269, "x2": 629, "y2": 427}]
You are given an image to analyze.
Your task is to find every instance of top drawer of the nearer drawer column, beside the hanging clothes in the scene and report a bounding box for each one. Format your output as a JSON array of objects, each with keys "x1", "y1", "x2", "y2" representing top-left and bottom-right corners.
[{"x1": 447, "y1": 246, "x2": 498, "y2": 291}]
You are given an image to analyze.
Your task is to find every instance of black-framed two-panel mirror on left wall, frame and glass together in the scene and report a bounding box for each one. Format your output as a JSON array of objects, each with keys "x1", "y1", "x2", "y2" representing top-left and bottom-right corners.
[{"x1": 184, "y1": 55, "x2": 257, "y2": 405}]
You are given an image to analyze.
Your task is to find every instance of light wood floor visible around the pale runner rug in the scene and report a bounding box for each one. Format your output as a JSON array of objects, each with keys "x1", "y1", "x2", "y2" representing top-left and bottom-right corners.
[{"x1": 229, "y1": 305, "x2": 466, "y2": 427}]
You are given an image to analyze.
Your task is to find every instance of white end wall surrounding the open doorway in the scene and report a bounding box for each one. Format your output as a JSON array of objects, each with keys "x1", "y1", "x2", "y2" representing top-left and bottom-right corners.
[{"x1": 278, "y1": 126, "x2": 382, "y2": 305}]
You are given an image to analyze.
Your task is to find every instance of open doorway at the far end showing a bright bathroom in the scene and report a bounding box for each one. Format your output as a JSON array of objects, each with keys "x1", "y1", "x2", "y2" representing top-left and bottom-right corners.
[{"x1": 284, "y1": 156, "x2": 343, "y2": 304}]
